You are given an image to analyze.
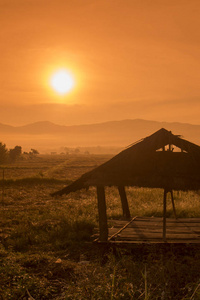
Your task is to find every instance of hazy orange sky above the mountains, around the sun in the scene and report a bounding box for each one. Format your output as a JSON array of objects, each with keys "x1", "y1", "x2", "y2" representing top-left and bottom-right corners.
[{"x1": 0, "y1": 0, "x2": 200, "y2": 125}]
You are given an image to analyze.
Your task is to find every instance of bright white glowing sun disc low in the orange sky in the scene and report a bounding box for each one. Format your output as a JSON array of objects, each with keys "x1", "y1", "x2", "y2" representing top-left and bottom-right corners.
[{"x1": 50, "y1": 69, "x2": 75, "y2": 95}]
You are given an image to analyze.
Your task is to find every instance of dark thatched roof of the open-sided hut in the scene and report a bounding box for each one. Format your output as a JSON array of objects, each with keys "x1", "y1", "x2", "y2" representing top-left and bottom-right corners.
[{"x1": 52, "y1": 128, "x2": 200, "y2": 196}]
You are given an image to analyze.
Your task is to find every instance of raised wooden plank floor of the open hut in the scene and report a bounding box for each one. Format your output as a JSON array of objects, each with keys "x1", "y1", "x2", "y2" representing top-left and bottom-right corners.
[{"x1": 104, "y1": 217, "x2": 200, "y2": 243}]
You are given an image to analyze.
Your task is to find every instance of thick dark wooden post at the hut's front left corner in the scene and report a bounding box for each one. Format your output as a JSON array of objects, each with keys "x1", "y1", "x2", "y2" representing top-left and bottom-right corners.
[{"x1": 97, "y1": 186, "x2": 108, "y2": 242}]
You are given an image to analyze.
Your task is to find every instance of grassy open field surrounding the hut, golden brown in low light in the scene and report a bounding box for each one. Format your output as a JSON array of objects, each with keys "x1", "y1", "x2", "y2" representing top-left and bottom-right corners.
[{"x1": 0, "y1": 155, "x2": 200, "y2": 300}]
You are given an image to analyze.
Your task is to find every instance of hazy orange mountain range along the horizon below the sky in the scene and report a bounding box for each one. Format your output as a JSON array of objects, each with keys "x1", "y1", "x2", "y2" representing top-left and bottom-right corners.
[{"x1": 0, "y1": 119, "x2": 200, "y2": 152}]
